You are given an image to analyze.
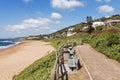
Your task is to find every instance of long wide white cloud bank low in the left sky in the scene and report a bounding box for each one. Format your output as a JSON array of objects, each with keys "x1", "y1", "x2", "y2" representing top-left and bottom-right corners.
[{"x1": 7, "y1": 18, "x2": 51, "y2": 31}]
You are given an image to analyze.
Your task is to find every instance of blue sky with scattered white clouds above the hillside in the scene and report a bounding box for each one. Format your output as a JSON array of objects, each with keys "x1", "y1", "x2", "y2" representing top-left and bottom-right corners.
[{"x1": 0, "y1": 0, "x2": 120, "y2": 38}]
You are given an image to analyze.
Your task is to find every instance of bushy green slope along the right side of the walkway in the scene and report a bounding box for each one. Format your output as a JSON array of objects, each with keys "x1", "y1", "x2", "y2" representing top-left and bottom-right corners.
[{"x1": 89, "y1": 26, "x2": 120, "y2": 62}]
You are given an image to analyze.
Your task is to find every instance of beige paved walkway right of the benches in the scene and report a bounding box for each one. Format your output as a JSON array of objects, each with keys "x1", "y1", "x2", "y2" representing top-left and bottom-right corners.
[{"x1": 76, "y1": 44, "x2": 120, "y2": 80}]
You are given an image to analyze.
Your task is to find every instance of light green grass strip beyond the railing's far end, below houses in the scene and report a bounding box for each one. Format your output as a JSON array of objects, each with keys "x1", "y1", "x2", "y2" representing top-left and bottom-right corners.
[{"x1": 46, "y1": 33, "x2": 89, "y2": 49}]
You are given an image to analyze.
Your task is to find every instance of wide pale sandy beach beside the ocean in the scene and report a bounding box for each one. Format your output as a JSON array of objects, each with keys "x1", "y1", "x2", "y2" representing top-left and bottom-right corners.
[{"x1": 0, "y1": 41, "x2": 54, "y2": 80}]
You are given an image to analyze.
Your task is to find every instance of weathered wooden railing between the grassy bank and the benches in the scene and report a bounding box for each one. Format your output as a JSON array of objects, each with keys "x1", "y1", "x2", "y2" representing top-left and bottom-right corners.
[{"x1": 51, "y1": 44, "x2": 75, "y2": 80}]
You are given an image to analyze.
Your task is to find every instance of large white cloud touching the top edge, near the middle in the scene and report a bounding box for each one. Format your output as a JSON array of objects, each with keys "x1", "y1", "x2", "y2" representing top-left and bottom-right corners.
[{"x1": 51, "y1": 0, "x2": 84, "y2": 9}]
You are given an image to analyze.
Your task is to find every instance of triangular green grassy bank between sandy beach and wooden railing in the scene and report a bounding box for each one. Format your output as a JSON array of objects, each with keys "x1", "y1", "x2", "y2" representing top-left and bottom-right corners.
[{"x1": 13, "y1": 52, "x2": 56, "y2": 80}]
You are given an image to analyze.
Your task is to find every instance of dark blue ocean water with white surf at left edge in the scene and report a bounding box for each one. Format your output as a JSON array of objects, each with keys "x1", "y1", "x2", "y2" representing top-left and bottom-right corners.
[{"x1": 0, "y1": 39, "x2": 20, "y2": 50}]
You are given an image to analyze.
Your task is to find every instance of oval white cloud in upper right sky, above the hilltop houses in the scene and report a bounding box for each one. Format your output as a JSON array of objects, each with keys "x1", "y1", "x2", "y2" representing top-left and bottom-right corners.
[{"x1": 98, "y1": 5, "x2": 115, "y2": 13}]
